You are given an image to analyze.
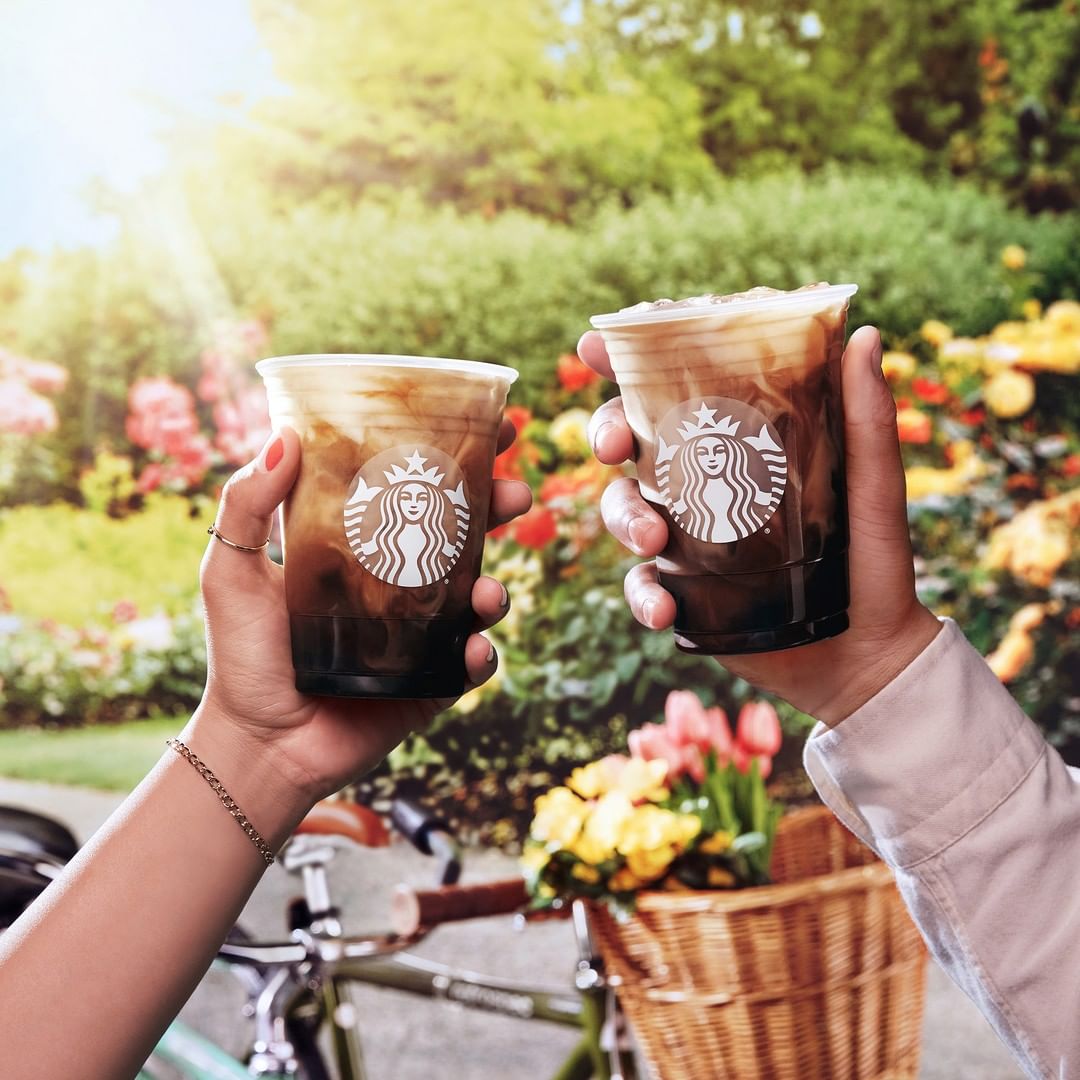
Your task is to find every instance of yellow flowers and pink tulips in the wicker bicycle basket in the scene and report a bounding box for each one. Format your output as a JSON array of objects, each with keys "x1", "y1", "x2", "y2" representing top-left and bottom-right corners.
[{"x1": 523, "y1": 691, "x2": 781, "y2": 914}]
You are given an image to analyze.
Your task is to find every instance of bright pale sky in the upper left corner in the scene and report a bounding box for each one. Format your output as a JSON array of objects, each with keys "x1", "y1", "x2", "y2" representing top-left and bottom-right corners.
[{"x1": 0, "y1": 0, "x2": 275, "y2": 258}]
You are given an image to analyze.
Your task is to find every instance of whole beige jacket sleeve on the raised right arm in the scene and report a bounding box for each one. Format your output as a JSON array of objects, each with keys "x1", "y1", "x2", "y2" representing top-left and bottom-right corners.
[{"x1": 805, "y1": 621, "x2": 1080, "y2": 1080}]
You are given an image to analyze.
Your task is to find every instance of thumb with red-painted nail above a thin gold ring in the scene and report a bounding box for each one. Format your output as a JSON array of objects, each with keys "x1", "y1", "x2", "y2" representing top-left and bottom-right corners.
[{"x1": 211, "y1": 428, "x2": 300, "y2": 558}]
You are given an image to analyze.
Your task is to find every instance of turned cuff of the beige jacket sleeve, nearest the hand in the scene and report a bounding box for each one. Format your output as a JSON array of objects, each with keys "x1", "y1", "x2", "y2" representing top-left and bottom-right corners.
[{"x1": 804, "y1": 619, "x2": 1045, "y2": 868}]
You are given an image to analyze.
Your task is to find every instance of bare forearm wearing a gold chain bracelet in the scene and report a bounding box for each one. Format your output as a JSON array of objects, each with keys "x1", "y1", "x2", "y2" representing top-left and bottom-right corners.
[{"x1": 0, "y1": 714, "x2": 307, "y2": 1080}]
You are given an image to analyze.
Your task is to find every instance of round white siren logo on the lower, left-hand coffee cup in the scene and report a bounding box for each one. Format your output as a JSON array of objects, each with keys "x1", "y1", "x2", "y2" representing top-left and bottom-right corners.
[{"x1": 345, "y1": 446, "x2": 470, "y2": 588}]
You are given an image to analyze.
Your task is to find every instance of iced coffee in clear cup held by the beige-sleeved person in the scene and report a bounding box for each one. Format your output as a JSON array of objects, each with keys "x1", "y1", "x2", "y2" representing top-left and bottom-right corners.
[{"x1": 593, "y1": 283, "x2": 856, "y2": 654}]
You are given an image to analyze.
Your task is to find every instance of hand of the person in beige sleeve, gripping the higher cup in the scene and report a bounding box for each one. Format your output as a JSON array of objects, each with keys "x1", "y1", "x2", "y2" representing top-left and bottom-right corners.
[{"x1": 578, "y1": 326, "x2": 940, "y2": 726}]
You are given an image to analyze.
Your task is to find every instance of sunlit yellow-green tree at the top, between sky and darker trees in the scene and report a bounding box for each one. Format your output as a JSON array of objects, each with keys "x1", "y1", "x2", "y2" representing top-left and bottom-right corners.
[{"x1": 212, "y1": 0, "x2": 711, "y2": 215}]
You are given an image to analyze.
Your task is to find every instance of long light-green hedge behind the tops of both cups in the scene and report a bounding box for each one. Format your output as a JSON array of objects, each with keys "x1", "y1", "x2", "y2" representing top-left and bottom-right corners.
[{"x1": 0, "y1": 172, "x2": 1080, "y2": 497}]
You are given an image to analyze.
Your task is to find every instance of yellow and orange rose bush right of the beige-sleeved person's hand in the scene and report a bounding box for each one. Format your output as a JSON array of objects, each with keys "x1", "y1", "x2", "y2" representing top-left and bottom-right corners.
[{"x1": 882, "y1": 293, "x2": 1080, "y2": 759}]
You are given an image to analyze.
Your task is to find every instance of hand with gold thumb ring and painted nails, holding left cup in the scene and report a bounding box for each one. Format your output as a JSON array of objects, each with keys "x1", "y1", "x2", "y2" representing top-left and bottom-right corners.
[{"x1": 185, "y1": 420, "x2": 532, "y2": 813}]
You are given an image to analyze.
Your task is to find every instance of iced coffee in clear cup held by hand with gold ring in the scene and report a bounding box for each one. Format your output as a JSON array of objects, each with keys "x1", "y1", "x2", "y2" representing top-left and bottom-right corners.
[{"x1": 257, "y1": 355, "x2": 517, "y2": 698}]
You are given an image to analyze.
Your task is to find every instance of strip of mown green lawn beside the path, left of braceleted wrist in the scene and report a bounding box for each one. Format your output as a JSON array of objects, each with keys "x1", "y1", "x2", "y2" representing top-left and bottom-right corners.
[{"x1": 0, "y1": 716, "x2": 187, "y2": 792}]
